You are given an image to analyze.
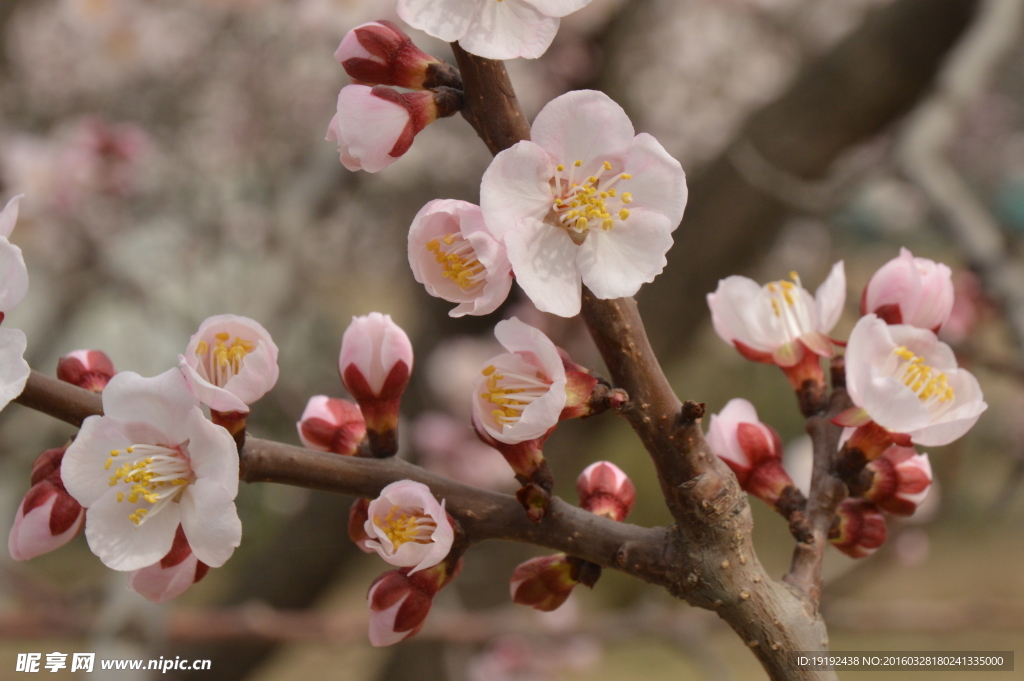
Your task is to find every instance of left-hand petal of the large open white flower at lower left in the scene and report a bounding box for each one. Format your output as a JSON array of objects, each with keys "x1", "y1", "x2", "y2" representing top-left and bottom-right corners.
[{"x1": 60, "y1": 416, "x2": 135, "y2": 508}]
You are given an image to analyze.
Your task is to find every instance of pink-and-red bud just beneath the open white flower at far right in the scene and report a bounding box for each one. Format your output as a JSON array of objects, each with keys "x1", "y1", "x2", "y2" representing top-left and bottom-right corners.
[{"x1": 863, "y1": 444, "x2": 932, "y2": 515}]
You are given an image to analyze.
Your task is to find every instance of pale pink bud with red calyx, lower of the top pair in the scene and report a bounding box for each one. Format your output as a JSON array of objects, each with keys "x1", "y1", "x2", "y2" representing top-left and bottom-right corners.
[{"x1": 326, "y1": 85, "x2": 463, "y2": 173}]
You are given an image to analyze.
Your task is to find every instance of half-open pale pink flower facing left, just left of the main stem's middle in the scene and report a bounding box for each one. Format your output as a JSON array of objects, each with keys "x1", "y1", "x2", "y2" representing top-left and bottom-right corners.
[{"x1": 473, "y1": 317, "x2": 566, "y2": 444}]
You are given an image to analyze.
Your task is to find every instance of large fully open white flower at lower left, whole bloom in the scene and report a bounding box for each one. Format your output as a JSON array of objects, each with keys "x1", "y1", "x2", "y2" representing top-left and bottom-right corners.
[{"x1": 61, "y1": 369, "x2": 242, "y2": 570}]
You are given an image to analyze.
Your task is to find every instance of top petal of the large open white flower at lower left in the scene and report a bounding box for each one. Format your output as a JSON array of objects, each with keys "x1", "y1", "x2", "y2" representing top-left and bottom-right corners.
[{"x1": 103, "y1": 369, "x2": 199, "y2": 446}]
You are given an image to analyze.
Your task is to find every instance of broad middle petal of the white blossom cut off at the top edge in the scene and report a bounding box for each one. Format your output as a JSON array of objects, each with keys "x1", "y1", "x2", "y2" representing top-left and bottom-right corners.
[{"x1": 459, "y1": 0, "x2": 558, "y2": 59}]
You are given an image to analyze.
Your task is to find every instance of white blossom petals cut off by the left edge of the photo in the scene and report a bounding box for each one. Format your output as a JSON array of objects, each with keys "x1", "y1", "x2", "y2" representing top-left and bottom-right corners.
[{"x1": 0, "y1": 194, "x2": 32, "y2": 410}]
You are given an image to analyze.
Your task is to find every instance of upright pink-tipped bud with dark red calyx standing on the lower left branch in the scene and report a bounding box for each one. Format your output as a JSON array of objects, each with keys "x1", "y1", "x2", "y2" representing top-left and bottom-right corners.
[{"x1": 338, "y1": 312, "x2": 413, "y2": 457}]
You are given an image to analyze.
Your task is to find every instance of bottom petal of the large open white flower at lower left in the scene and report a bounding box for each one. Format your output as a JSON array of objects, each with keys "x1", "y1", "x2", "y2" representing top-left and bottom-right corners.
[{"x1": 84, "y1": 485, "x2": 180, "y2": 570}]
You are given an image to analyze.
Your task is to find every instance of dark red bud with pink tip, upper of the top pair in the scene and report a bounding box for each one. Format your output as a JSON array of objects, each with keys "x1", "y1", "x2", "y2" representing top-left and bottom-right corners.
[{"x1": 334, "y1": 19, "x2": 462, "y2": 90}]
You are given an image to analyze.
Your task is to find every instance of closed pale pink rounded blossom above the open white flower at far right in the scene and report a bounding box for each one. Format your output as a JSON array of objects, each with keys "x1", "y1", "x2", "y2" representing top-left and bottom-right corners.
[{"x1": 860, "y1": 248, "x2": 953, "y2": 333}]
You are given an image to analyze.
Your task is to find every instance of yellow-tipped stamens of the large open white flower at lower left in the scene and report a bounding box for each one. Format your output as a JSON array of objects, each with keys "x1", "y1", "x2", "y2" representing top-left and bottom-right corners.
[{"x1": 103, "y1": 444, "x2": 196, "y2": 525}]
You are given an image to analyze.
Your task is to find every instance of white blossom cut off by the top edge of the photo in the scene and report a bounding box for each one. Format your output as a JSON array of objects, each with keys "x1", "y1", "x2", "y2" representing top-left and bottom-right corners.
[{"x1": 398, "y1": 0, "x2": 590, "y2": 59}]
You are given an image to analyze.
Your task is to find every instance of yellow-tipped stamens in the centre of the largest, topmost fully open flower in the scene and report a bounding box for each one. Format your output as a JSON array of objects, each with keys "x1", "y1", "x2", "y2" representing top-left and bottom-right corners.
[{"x1": 551, "y1": 160, "x2": 633, "y2": 246}]
